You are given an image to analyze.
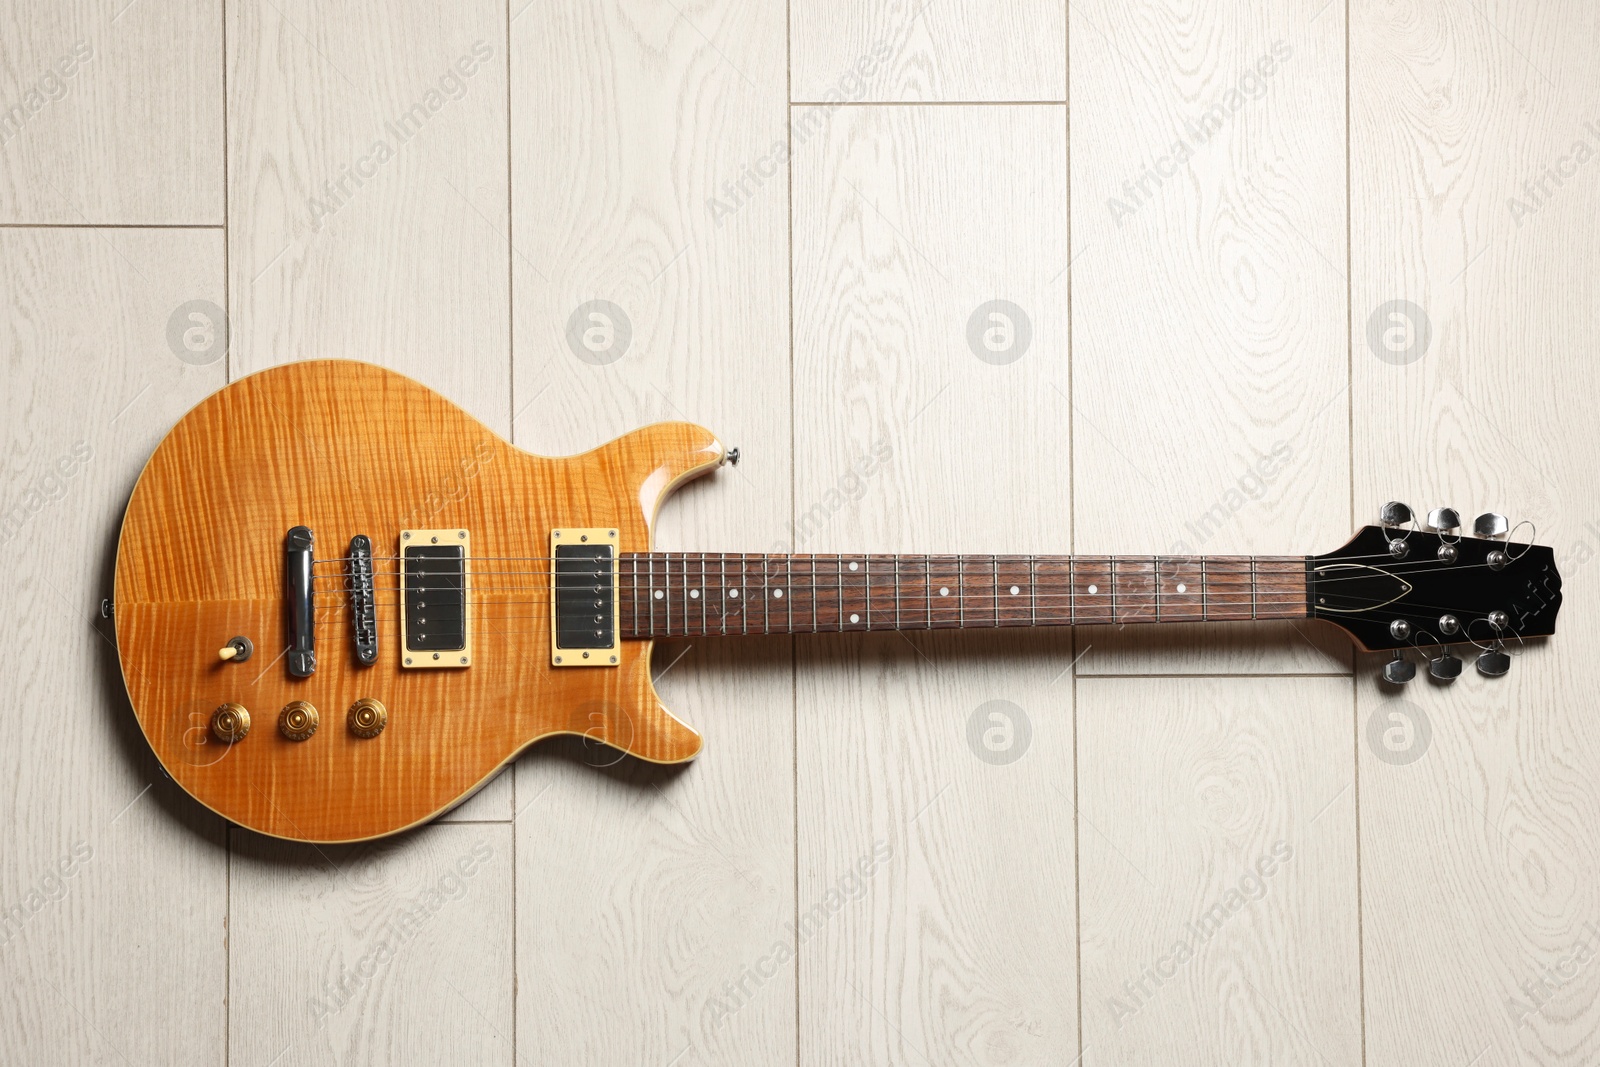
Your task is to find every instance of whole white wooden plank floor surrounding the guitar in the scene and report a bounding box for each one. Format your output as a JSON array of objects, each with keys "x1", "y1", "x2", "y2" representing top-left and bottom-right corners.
[{"x1": 0, "y1": 0, "x2": 1600, "y2": 1067}]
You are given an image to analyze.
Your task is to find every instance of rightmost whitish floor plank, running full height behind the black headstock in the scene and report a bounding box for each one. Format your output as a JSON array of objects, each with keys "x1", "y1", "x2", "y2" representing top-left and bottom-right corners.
[{"x1": 1350, "y1": 3, "x2": 1600, "y2": 1064}]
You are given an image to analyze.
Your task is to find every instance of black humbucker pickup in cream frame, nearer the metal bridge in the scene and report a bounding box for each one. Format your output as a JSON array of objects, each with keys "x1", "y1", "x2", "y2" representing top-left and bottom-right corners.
[{"x1": 400, "y1": 530, "x2": 472, "y2": 667}]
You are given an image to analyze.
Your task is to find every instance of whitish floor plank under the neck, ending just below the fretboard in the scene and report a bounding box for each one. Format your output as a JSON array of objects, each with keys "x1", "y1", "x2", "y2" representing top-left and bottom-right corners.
[{"x1": 1070, "y1": 0, "x2": 1352, "y2": 673}]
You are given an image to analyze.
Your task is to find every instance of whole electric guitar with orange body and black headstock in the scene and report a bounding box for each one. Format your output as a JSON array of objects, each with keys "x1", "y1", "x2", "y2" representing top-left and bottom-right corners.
[{"x1": 106, "y1": 360, "x2": 1562, "y2": 841}]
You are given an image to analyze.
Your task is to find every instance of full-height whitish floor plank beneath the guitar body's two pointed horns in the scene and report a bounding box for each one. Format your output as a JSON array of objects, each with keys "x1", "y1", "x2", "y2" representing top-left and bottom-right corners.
[{"x1": 510, "y1": 0, "x2": 795, "y2": 1067}]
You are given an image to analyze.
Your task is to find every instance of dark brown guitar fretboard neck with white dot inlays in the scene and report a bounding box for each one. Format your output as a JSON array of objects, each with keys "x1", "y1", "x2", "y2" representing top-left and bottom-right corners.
[{"x1": 618, "y1": 552, "x2": 1310, "y2": 640}]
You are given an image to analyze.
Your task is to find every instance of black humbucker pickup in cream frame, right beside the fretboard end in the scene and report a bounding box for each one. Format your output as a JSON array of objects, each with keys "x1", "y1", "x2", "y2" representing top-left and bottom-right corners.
[{"x1": 550, "y1": 530, "x2": 621, "y2": 667}]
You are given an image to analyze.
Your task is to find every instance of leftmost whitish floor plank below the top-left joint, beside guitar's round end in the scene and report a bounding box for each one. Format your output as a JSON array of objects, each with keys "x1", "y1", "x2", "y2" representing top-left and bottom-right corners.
[{"x1": 0, "y1": 229, "x2": 227, "y2": 1064}]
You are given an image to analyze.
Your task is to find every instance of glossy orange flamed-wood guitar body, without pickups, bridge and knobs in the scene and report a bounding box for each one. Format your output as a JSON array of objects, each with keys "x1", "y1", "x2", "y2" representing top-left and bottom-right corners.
[{"x1": 115, "y1": 360, "x2": 725, "y2": 841}]
